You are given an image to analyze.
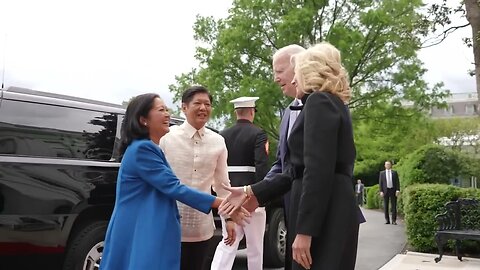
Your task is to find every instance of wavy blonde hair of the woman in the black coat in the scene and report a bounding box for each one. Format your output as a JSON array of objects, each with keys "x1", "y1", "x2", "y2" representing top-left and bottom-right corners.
[{"x1": 292, "y1": 42, "x2": 352, "y2": 103}]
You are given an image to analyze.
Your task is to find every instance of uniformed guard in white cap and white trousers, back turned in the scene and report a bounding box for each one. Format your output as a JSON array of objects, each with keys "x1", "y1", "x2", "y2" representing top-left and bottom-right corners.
[{"x1": 211, "y1": 97, "x2": 270, "y2": 270}]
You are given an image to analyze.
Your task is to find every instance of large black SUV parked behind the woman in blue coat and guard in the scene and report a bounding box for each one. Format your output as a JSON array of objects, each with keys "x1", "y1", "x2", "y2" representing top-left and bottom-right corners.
[{"x1": 0, "y1": 87, "x2": 286, "y2": 270}]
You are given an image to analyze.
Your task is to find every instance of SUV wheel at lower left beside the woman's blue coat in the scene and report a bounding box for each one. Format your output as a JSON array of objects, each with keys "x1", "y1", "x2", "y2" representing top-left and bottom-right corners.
[{"x1": 63, "y1": 221, "x2": 108, "y2": 270}]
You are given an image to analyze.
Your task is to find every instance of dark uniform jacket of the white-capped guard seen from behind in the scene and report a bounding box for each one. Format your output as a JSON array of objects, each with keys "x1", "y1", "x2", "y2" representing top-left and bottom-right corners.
[{"x1": 220, "y1": 119, "x2": 269, "y2": 187}]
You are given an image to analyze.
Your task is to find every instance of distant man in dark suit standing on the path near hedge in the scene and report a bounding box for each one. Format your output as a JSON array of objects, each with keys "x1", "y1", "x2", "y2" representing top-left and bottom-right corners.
[{"x1": 378, "y1": 160, "x2": 400, "y2": 225}]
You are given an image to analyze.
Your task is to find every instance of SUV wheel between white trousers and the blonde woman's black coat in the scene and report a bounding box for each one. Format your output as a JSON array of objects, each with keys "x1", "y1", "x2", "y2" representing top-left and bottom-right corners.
[{"x1": 263, "y1": 208, "x2": 287, "y2": 267}]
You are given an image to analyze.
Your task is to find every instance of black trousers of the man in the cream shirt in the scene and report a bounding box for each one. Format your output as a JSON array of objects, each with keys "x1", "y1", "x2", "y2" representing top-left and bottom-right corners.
[{"x1": 180, "y1": 239, "x2": 211, "y2": 270}]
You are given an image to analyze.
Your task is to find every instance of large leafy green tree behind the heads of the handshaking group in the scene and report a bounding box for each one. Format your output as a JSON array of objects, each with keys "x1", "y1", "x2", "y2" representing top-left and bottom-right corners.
[{"x1": 170, "y1": 0, "x2": 446, "y2": 158}]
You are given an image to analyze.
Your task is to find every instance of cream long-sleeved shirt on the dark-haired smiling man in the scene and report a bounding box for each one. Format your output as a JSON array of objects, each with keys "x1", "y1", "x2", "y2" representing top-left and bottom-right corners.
[{"x1": 160, "y1": 121, "x2": 230, "y2": 242}]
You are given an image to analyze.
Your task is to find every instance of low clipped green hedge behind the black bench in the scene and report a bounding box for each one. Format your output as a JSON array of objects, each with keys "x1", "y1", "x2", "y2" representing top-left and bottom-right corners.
[{"x1": 403, "y1": 184, "x2": 480, "y2": 252}]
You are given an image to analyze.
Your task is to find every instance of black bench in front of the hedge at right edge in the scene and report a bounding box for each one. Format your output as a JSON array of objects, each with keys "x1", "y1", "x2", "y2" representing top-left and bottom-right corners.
[{"x1": 435, "y1": 199, "x2": 480, "y2": 263}]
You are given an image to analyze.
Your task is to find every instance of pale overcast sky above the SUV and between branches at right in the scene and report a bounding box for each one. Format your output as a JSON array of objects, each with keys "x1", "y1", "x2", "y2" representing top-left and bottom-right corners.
[{"x1": 0, "y1": 0, "x2": 475, "y2": 108}]
